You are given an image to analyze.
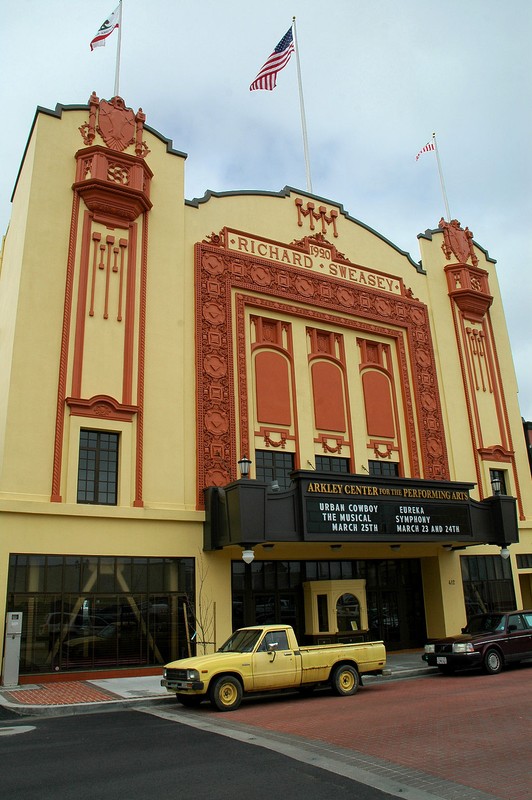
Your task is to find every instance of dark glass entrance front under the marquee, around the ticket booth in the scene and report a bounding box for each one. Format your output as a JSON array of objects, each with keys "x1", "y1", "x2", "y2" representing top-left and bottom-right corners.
[{"x1": 232, "y1": 559, "x2": 426, "y2": 650}]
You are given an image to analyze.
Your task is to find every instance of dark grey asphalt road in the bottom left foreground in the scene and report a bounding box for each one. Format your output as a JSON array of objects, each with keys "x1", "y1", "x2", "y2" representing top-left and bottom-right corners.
[{"x1": 0, "y1": 710, "x2": 402, "y2": 800}]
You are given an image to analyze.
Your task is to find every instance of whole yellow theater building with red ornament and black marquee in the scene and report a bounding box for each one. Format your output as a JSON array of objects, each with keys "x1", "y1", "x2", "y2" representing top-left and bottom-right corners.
[{"x1": 0, "y1": 94, "x2": 532, "y2": 681}]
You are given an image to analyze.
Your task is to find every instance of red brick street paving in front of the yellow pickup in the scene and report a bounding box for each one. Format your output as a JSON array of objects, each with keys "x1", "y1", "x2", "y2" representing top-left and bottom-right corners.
[{"x1": 224, "y1": 665, "x2": 532, "y2": 800}]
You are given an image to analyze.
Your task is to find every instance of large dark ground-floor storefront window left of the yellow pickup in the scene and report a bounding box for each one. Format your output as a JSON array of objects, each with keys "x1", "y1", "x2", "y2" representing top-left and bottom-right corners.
[{"x1": 7, "y1": 554, "x2": 195, "y2": 675}]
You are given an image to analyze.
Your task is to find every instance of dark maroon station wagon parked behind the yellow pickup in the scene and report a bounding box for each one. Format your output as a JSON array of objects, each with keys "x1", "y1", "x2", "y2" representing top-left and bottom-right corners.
[{"x1": 422, "y1": 611, "x2": 532, "y2": 675}]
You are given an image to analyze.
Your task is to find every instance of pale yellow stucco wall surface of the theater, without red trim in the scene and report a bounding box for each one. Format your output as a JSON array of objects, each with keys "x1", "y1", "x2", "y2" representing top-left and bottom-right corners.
[{"x1": 0, "y1": 100, "x2": 532, "y2": 668}]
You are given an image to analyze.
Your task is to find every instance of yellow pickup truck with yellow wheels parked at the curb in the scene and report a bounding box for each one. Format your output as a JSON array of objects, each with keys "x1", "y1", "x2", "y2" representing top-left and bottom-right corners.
[{"x1": 161, "y1": 625, "x2": 386, "y2": 711}]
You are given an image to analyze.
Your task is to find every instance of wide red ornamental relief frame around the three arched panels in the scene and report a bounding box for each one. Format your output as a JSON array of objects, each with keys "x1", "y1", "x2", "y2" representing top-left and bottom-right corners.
[{"x1": 195, "y1": 232, "x2": 449, "y2": 507}]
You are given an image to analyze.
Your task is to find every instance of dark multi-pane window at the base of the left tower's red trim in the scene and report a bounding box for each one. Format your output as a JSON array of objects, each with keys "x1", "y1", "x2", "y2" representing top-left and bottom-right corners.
[{"x1": 78, "y1": 430, "x2": 118, "y2": 506}]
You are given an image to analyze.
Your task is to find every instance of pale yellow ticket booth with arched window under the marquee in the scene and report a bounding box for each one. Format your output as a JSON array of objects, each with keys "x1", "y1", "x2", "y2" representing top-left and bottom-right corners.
[{"x1": 303, "y1": 580, "x2": 368, "y2": 644}]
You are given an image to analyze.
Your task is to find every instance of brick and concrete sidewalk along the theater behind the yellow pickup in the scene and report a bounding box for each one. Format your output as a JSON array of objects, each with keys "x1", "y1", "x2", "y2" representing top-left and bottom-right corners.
[{"x1": 0, "y1": 650, "x2": 436, "y2": 719}]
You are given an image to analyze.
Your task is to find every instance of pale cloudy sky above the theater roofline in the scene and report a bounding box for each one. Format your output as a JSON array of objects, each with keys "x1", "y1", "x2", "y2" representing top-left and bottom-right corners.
[{"x1": 0, "y1": 0, "x2": 532, "y2": 420}]
